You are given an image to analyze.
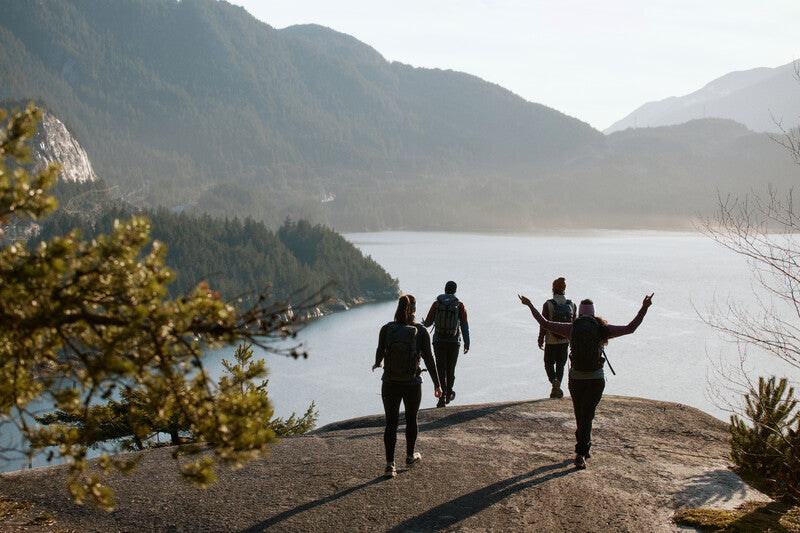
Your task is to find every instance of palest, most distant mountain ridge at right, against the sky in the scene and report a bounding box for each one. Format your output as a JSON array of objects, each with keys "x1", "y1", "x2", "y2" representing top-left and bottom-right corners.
[{"x1": 604, "y1": 63, "x2": 800, "y2": 134}]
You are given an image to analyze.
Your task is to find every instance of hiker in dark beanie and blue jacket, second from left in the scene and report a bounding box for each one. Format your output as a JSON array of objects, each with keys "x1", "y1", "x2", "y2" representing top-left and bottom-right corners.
[{"x1": 422, "y1": 281, "x2": 469, "y2": 407}]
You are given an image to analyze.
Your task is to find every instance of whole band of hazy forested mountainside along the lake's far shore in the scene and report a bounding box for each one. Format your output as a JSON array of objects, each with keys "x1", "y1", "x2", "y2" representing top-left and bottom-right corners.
[{"x1": 0, "y1": 0, "x2": 800, "y2": 231}]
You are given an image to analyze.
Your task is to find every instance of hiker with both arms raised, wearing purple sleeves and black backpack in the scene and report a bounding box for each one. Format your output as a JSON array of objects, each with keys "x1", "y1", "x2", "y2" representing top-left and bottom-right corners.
[{"x1": 517, "y1": 294, "x2": 653, "y2": 469}]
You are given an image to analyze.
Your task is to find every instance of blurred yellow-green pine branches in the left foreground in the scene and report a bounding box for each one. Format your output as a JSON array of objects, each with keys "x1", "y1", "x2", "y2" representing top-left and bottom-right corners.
[{"x1": 0, "y1": 106, "x2": 319, "y2": 508}]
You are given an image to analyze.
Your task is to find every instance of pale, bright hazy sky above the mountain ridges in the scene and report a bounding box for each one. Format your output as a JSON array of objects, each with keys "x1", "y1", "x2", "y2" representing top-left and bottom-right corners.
[{"x1": 231, "y1": 0, "x2": 800, "y2": 130}]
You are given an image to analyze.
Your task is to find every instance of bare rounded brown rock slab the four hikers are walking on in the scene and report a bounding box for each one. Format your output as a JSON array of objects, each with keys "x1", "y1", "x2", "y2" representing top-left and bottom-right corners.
[{"x1": 0, "y1": 396, "x2": 768, "y2": 533}]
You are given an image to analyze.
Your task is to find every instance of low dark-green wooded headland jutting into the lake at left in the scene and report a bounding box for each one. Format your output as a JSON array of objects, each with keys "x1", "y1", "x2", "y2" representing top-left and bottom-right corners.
[{"x1": 33, "y1": 182, "x2": 398, "y2": 306}]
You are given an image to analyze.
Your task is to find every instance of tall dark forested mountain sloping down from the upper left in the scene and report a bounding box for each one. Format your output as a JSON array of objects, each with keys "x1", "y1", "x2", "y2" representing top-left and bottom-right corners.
[{"x1": 0, "y1": 0, "x2": 602, "y2": 220}]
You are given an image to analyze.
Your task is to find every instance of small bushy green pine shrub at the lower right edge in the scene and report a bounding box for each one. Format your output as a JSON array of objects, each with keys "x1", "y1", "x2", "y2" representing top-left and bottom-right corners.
[{"x1": 730, "y1": 376, "x2": 798, "y2": 492}]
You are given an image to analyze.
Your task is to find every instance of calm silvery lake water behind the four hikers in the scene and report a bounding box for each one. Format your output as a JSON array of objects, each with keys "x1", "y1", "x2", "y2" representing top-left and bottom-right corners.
[{"x1": 207, "y1": 232, "x2": 786, "y2": 426}]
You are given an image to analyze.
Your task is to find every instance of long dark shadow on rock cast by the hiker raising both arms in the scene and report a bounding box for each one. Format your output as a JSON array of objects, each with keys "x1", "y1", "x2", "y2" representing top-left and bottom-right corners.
[{"x1": 388, "y1": 459, "x2": 576, "y2": 533}]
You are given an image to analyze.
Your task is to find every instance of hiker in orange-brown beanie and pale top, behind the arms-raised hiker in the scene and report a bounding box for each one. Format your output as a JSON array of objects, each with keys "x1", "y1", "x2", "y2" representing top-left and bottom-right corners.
[{"x1": 538, "y1": 278, "x2": 577, "y2": 398}]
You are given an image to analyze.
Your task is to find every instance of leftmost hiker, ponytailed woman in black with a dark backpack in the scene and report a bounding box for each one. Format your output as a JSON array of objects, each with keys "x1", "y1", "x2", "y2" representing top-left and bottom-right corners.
[{"x1": 372, "y1": 294, "x2": 442, "y2": 478}]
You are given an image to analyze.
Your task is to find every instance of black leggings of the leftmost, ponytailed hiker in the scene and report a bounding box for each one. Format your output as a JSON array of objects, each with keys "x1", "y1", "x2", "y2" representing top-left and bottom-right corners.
[{"x1": 381, "y1": 381, "x2": 422, "y2": 463}]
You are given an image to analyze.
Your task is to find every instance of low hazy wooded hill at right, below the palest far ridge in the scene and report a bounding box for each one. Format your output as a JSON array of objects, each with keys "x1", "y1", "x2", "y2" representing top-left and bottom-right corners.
[{"x1": 551, "y1": 117, "x2": 800, "y2": 229}]
